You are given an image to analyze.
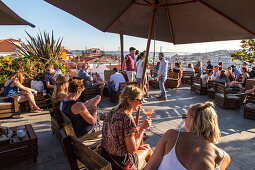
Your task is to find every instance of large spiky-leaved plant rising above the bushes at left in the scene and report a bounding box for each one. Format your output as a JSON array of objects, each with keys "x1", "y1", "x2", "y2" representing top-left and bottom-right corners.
[{"x1": 13, "y1": 31, "x2": 63, "y2": 65}]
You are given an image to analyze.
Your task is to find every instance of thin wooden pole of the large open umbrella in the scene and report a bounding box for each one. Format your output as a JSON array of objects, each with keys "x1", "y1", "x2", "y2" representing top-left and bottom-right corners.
[{"x1": 135, "y1": 0, "x2": 158, "y2": 127}]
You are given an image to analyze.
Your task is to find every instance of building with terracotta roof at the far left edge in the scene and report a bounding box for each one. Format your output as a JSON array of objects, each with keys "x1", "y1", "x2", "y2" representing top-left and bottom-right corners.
[{"x1": 0, "y1": 38, "x2": 21, "y2": 57}]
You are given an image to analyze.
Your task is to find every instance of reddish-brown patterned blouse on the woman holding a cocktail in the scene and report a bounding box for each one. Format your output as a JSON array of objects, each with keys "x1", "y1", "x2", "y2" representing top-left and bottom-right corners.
[{"x1": 101, "y1": 109, "x2": 138, "y2": 156}]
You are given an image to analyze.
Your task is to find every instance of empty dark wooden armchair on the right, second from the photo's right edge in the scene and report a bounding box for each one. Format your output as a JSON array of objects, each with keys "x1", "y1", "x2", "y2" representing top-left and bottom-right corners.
[{"x1": 215, "y1": 83, "x2": 241, "y2": 110}]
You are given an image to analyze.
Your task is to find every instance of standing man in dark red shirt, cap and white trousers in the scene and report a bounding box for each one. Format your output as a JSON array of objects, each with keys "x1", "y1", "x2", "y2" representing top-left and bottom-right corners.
[{"x1": 121, "y1": 47, "x2": 136, "y2": 82}]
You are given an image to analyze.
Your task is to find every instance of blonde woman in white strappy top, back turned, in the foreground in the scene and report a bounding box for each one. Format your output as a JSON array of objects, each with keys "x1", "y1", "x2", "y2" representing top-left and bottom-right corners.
[{"x1": 145, "y1": 102, "x2": 230, "y2": 170}]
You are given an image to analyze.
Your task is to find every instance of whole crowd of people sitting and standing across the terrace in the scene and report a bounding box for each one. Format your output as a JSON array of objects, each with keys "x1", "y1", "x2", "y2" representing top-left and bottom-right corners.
[{"x1": 4, "y1": 47, "x2": 255, "y2": 170}]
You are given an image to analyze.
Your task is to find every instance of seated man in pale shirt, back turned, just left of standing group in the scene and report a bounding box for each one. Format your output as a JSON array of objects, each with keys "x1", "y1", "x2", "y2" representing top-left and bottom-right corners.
[{"x1": 108, "y1": 67, "x2": 126, "y2": 96}]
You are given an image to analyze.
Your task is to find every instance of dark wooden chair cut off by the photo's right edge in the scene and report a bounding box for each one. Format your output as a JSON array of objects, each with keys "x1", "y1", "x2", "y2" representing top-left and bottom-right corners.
[{"x1": 244, "y1": 94, "x2": 255, "y2": 120}]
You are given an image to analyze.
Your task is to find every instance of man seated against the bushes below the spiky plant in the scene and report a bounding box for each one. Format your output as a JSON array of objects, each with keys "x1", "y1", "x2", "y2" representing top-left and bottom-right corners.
[{"x1": 45, "y1": 64, "x2": 62, "y2": 95}]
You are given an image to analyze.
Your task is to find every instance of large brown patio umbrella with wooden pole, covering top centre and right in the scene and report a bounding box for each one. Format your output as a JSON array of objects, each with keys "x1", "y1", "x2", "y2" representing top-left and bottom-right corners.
[{"x1": 45, "y1": 0, "x2": 255, "y2": 123}]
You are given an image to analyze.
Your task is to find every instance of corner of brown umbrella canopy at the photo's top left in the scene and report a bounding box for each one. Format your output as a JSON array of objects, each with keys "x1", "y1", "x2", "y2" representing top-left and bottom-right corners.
[{"x1": 0, "y1": 1, "x2": 35, "y2": 27}]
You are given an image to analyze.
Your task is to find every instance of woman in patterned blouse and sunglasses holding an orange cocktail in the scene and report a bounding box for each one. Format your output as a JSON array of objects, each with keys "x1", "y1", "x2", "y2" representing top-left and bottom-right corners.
[{"x1": 101, "y1": 85, "x2": 152, "y2": 169}]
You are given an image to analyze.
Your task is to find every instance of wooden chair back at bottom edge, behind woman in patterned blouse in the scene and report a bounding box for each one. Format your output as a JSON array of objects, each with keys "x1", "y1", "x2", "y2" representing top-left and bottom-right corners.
[{"x1": 62, "y1": 136, "x2": 112, "y2": 170}]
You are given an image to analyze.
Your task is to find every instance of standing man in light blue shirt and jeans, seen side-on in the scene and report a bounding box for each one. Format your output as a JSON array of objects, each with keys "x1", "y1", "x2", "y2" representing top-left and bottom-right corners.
[{"x1": 157, "y1": 53, "x2": 167, "y2": 101}]
